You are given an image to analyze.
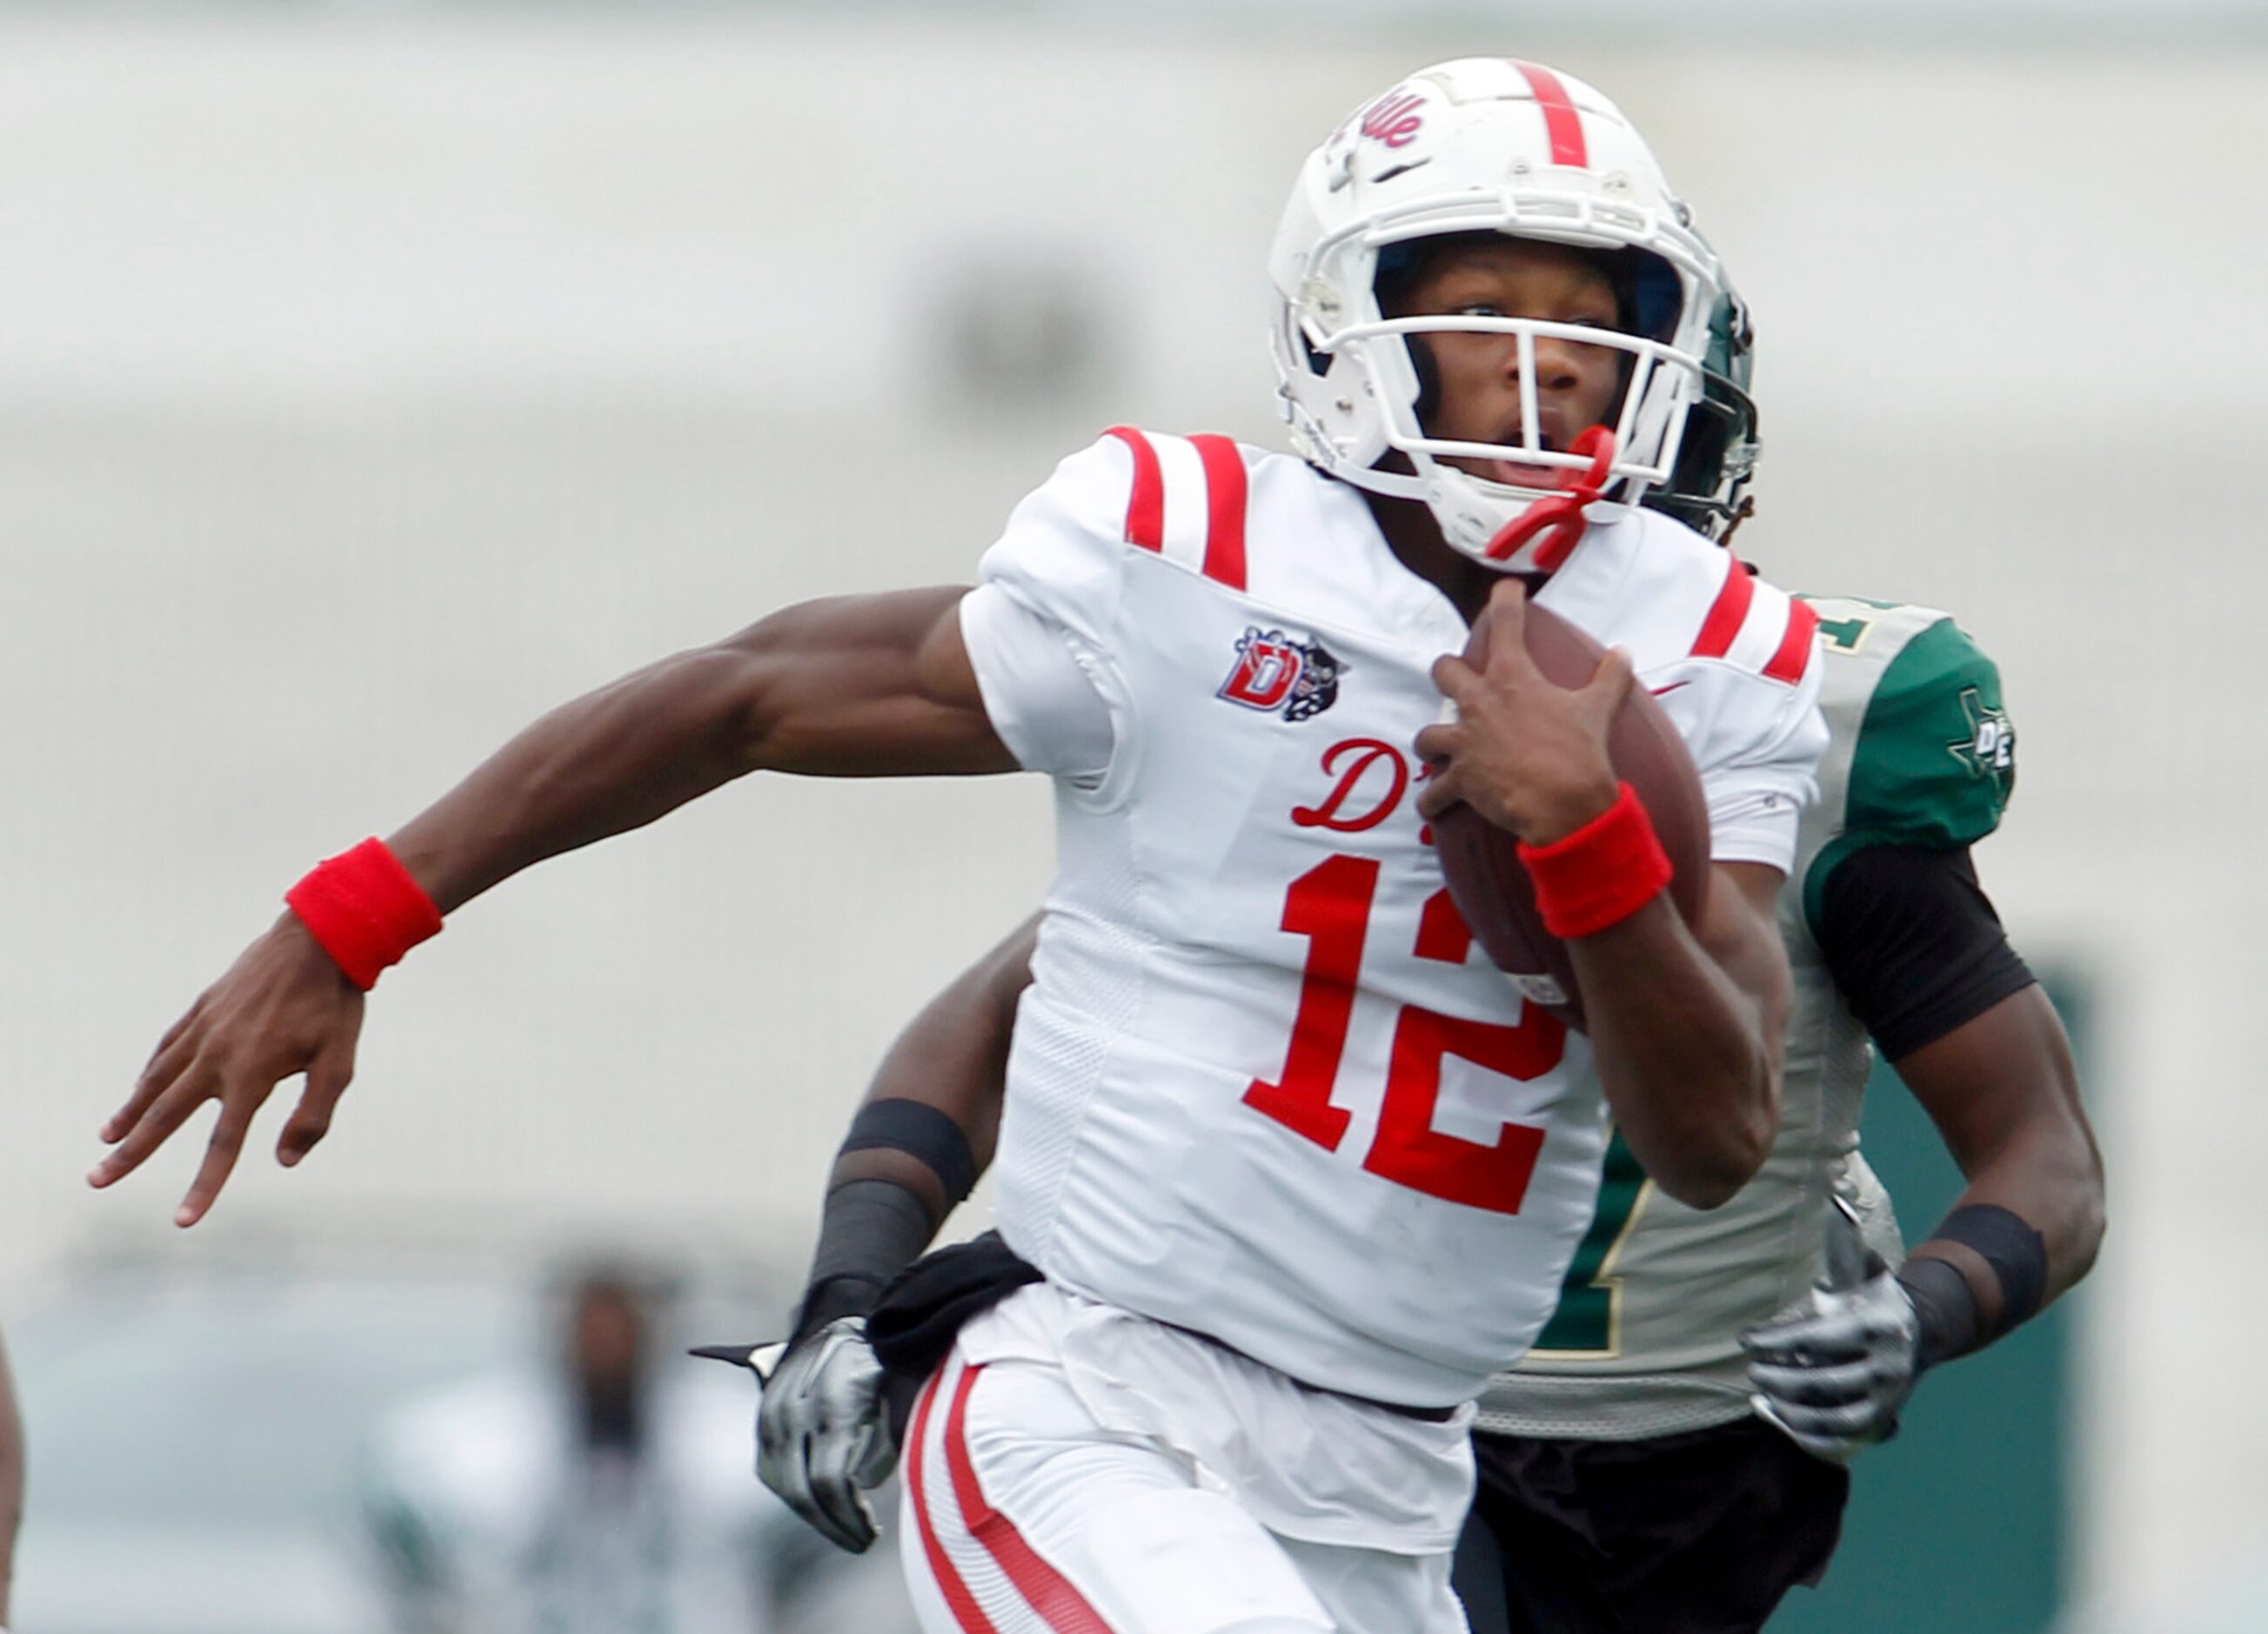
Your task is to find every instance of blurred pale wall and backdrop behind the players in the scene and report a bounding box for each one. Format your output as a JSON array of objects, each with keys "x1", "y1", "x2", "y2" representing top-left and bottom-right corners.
[{"x1": 0, "y1": 0, "x2": 2268, "y2": 1634}]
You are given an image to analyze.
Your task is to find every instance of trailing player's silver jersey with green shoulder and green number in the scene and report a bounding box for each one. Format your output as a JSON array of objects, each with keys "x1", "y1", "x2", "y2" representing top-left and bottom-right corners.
[{"x1": 1475, "y1": 597, "x2": 2017, "y2": 1441}]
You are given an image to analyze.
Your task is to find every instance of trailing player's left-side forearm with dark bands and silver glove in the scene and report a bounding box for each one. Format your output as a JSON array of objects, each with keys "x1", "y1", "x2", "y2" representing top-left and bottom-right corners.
[{"x1": 755, "y1": 914, "x2": 1039, "y2": 1552}]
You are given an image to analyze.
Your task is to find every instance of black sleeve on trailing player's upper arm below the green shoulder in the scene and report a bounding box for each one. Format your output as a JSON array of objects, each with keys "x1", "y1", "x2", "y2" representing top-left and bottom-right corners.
[{"x1": 1815, "y1": 847, "x2": 2032, "y2": 1062}]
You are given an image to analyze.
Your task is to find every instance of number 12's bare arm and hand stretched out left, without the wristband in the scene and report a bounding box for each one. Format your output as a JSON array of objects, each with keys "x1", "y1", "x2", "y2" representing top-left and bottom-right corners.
[{"x1": 89, "y1": 586, "x2": 1016, "y2": 1226}]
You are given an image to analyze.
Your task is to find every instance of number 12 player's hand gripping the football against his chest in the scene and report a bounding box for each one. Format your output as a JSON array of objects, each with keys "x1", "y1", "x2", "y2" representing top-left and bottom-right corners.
[{"x1": 1417, "y1": 579, "x2": 1633, "y2": 844}]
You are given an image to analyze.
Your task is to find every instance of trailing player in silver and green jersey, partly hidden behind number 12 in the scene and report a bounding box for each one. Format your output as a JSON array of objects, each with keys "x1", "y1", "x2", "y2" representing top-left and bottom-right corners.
[{"x1": 734, "y1": 286, "x2": 2103, "y2": 1634}]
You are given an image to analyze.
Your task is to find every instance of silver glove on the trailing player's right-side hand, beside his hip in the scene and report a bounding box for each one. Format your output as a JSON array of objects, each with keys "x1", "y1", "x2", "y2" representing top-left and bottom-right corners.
[{"x1": 1740, "y1": 1198, "x2": 1921, "y2": 1463}]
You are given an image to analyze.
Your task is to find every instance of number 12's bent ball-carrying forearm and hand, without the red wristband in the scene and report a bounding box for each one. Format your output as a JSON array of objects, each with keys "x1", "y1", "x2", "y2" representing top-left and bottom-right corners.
[{"x1": 1417, "y1": 579, "x2": 1787, "y2": 1208}]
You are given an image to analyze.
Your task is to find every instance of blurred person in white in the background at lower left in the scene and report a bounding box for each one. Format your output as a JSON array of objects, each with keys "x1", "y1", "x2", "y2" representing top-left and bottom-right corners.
[{"x1": 365, "y1": 1271, "x2": 807, "y2": 1634}]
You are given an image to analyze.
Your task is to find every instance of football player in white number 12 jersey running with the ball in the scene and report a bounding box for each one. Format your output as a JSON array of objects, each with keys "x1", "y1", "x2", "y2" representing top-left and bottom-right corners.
[{"x1": 93, "y1": 59, "x2": 1826, "y2": 1634}]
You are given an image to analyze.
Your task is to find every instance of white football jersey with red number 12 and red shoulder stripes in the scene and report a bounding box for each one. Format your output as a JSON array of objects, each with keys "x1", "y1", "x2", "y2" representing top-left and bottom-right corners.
[{"x1": 961, "y1": 429, "x2": 1823, "y2": 1407}]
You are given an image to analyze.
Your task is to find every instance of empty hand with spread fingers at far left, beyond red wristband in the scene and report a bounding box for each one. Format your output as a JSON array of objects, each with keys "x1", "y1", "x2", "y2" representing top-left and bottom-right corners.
[{"x1": 86, "y1": 914, "x2": 363, "y2": 1226}]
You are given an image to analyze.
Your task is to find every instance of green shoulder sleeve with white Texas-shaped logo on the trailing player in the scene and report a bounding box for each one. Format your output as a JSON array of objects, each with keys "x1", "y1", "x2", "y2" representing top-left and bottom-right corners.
[{"x1": 1803, "y1": 617, "x2": 2017, "y2": 926}]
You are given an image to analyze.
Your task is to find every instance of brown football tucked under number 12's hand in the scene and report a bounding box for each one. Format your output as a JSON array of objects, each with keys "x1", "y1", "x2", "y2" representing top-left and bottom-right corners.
[{"x1": 1434, "y1": 601, "x2": 1708, "y2": 1033}]
